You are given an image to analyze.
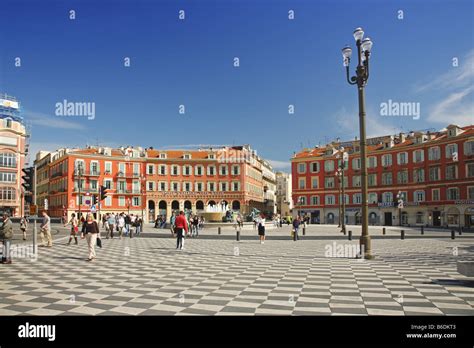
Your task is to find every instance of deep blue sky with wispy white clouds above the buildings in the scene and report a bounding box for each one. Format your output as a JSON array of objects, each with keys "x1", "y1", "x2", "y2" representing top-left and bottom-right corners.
[{"x1": 0, "y1": 0, "x2": 474, "y2": 169}]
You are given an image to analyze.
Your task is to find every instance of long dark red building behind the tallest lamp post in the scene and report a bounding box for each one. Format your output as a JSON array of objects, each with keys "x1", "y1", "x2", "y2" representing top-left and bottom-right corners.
[{"x1": 291, "y1": 125, "x2": 474, "y2": 227}]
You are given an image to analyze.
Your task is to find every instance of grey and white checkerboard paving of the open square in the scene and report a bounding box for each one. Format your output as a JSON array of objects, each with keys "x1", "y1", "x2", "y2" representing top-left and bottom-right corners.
[{"x1": 0, "y1": 234, "x2": 474, "y2": 315}]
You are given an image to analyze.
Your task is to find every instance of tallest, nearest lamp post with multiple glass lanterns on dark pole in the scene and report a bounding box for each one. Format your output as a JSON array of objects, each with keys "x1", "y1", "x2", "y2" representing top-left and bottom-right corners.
[{"x1": 342, "y1": 28, "x2": 372, "y2": 259}]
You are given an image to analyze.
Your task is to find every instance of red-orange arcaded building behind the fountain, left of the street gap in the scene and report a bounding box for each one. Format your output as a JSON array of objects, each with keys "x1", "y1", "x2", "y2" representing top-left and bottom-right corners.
[{"x1": 40, "y1": 145, "x2": 265, "y2": 221}]
